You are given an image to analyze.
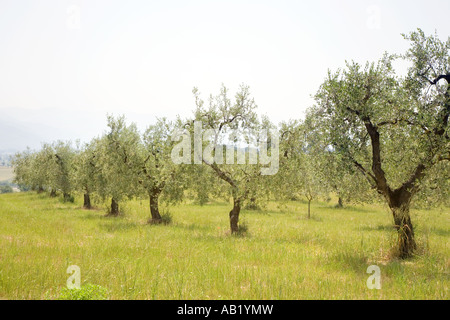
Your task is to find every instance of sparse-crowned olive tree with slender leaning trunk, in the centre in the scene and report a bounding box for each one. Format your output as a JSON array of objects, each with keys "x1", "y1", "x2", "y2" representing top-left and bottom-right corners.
[{"x1": 187, "y1": 85, "x2": 278, "y2": 234}]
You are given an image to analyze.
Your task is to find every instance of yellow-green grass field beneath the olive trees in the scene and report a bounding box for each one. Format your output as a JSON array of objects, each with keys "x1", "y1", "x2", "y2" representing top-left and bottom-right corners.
[{"x1": 0, "y1": 193, "x2": 450, "y2": 300}]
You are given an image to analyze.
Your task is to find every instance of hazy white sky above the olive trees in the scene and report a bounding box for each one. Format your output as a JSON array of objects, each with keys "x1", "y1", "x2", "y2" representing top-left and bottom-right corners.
[{"x1": 0, "y1": 0, "x2": 450, "y2": 149}]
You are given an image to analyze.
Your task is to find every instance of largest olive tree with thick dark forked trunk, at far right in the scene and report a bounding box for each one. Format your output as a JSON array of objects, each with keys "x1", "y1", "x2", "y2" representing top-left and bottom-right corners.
[{"x1": 314, "y1": 30, "x2": 450, "y2": 258}]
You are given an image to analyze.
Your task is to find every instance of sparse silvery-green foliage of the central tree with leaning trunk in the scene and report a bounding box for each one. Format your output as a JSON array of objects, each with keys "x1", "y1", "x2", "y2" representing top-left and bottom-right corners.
[{"x1": 190, "y1": 85, "x2": 271, "y2": 205}]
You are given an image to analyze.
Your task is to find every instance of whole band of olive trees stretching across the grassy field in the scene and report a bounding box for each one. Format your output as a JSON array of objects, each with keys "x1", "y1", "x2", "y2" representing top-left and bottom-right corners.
[{"x1": 8, "y1": 29, "x2": 450, "y2": 258}]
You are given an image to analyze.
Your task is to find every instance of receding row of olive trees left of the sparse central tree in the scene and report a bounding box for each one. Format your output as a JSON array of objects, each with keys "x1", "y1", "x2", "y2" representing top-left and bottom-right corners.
[{"x1": 13, "y1": 116, "x2": 183, "y2": 223}]
